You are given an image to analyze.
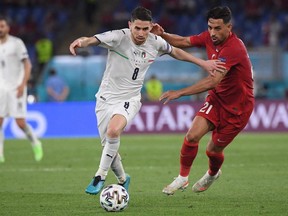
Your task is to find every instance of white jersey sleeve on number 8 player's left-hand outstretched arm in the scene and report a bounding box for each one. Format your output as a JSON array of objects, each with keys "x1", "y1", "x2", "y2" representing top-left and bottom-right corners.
[{"x1": 94, "y1": 30, "x2": 125, "y2": 49}]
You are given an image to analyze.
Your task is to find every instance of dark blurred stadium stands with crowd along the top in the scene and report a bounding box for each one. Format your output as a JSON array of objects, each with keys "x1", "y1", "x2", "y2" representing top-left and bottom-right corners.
[{"x1": 0, "y1": 0, "x2": 288, "y2": 100}]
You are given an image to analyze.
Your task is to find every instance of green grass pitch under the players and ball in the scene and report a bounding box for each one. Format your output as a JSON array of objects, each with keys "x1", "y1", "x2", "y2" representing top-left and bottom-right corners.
[{"x1": 0, "y1": 133, "x2": 288, "y2": 216}]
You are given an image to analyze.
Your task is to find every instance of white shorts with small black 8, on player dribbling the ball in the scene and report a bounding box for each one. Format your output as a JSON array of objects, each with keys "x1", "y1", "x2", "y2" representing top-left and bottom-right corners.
[{"x1": 95, "y1": 100, "x2": 142, "y2": 146}]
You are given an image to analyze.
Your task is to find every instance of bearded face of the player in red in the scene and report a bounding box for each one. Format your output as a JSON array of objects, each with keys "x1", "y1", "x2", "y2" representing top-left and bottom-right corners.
[{"x1": 208, "y1": 18, "x2": 232, "y2": 45}]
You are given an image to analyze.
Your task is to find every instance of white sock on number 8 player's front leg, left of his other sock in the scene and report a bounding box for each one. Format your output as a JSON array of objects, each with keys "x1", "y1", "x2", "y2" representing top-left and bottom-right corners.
[{"x1": 95, "y1": 137, "x2": 120, "y2": 180}]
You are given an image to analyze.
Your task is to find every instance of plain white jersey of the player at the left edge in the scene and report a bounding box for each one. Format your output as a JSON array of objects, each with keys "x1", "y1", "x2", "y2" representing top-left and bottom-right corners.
[{"x1": 0, "y1": 35, "x2": 29, "y2": 89}]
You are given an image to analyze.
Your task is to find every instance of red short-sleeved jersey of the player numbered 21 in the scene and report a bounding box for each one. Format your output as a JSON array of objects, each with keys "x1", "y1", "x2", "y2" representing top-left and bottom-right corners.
[{"x1": 190, "y1": 31, "x2": 254, "y2": 115}]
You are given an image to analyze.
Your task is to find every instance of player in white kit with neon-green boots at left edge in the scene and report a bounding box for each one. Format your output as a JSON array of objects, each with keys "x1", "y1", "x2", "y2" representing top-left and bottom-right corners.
[{"x1": 0, "y1": 17, "x2": 43, "y2": 163}]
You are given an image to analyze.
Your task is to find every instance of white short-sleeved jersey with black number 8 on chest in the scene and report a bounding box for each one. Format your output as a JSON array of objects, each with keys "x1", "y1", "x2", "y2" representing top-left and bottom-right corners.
[{"x1": 95, "y1": 28, "x2": 172, "y2": 104}]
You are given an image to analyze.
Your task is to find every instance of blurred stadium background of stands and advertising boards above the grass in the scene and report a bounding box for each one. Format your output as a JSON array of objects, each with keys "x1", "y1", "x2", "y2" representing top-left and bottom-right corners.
[{"x1": 0, "y1": 0, "x2": 288, "y2": 138}]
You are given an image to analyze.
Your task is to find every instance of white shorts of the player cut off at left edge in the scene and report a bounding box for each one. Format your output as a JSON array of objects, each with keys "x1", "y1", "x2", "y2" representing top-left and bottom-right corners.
[{"x1": 0, "y1": 88, "x2": 27, "y2": 118}]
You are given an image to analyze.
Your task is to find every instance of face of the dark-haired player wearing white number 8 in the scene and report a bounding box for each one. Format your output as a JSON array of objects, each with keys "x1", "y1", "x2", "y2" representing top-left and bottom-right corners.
[{"x1": 129, "y1": 20, "x2": 152, "y2": 45}]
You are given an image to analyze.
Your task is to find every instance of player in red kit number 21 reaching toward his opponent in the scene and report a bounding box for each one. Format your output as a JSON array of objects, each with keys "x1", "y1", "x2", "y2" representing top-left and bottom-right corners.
[{"x1": 152, "y1": 7, "x2": 254, "y2": 195}]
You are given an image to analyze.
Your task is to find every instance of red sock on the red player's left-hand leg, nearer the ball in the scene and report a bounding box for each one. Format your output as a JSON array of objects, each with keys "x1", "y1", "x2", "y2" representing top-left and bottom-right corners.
[{"x1": 180, "y1": 137, "x2": 199, "y2": 177}]
